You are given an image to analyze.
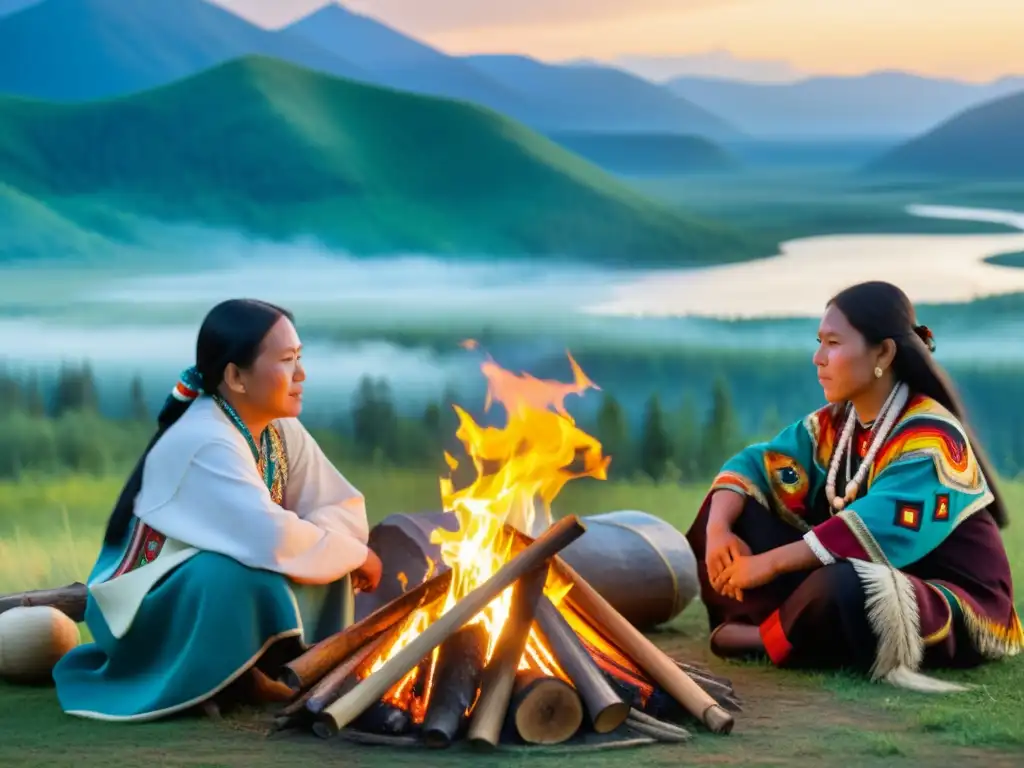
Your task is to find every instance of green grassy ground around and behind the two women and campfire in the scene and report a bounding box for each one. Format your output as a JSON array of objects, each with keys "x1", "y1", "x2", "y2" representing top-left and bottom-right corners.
[{"x1": 0, "y1": 468, "x2": 1024, "y2": 768}]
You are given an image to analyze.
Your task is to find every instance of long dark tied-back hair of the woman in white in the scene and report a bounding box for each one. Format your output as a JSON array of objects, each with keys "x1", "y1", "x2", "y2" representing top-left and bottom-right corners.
[{"x1": 103, "y1": 299, "x2": 295, "y2": 546}]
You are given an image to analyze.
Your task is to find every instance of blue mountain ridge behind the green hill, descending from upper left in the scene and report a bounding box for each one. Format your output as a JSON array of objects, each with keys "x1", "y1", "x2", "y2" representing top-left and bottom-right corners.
[{"x1": 0, "y1": 0, "x2": 739, "y2": 138}]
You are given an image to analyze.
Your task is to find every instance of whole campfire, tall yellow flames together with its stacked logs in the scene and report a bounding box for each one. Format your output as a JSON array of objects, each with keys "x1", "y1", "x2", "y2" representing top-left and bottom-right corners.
[{"x1": 278, "y1": 356, "x2": 737, "y2": 748}]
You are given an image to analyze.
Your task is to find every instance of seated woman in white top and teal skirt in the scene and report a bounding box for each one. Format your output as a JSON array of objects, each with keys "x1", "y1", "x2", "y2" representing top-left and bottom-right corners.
[{"x1": 53, "y1": 300, "x2": 381, "y2": 721}]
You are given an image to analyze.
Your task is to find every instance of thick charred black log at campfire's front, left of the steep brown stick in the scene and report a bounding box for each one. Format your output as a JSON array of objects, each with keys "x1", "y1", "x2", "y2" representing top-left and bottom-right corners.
[{"x1": 423, "y1": 624, "x2": 488, "y2": 748}]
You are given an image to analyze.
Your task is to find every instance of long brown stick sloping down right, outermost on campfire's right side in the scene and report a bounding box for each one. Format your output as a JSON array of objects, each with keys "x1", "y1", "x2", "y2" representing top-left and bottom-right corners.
[{"x1": 553, "y1": 557, "x2": 734, "y2": 733}]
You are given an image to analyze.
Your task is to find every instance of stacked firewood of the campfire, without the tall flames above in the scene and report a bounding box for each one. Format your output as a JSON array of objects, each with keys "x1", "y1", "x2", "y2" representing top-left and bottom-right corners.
[{"x1": 276, "y1": 517, "x2": 739, "y2": 748}]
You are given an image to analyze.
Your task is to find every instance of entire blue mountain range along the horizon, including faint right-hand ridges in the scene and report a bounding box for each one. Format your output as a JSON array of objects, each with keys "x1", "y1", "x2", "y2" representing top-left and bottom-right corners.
[{"x1": 6, "y1": 0, "x2": 1024, "y2": 141}]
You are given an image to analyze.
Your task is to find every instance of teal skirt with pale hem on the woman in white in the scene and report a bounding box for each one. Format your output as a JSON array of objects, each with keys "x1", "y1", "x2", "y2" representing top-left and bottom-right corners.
[{"x1": 53, "y1": 552, "x2": 352, "y2": 721}]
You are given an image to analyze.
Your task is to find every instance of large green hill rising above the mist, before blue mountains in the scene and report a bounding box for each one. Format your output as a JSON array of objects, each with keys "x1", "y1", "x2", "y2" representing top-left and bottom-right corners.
[{"x1": 0, "y1": 56, "x2": 771, "y2": 264}]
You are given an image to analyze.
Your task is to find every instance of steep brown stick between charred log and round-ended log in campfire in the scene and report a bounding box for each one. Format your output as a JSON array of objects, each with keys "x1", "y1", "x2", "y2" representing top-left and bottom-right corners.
[{"x1": 467, "y1": 564, "x2": 552, "y2": 746}]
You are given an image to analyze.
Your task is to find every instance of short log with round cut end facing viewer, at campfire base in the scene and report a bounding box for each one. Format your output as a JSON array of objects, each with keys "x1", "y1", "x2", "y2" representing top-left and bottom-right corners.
[{"x1": 509, "y1": 670, "x2": 584, "y2": 744}]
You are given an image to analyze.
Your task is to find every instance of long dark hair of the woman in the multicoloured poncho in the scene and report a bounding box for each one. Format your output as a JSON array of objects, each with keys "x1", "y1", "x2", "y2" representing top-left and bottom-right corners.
[{"x1": 828, "y1": 281, "x2": 1009, "y2": 527}]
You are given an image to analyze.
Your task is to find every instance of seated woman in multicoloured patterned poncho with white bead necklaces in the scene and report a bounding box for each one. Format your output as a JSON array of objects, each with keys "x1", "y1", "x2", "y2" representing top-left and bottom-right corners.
[{"x1": 687, "y1": 283, "x2": 1024, "y2": 691}]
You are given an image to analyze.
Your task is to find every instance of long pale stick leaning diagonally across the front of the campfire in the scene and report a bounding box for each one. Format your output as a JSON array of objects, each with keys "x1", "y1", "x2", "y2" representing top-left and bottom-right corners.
[{"x1": 313, "y1": 516, "x2": 586, "y2": 733}]
